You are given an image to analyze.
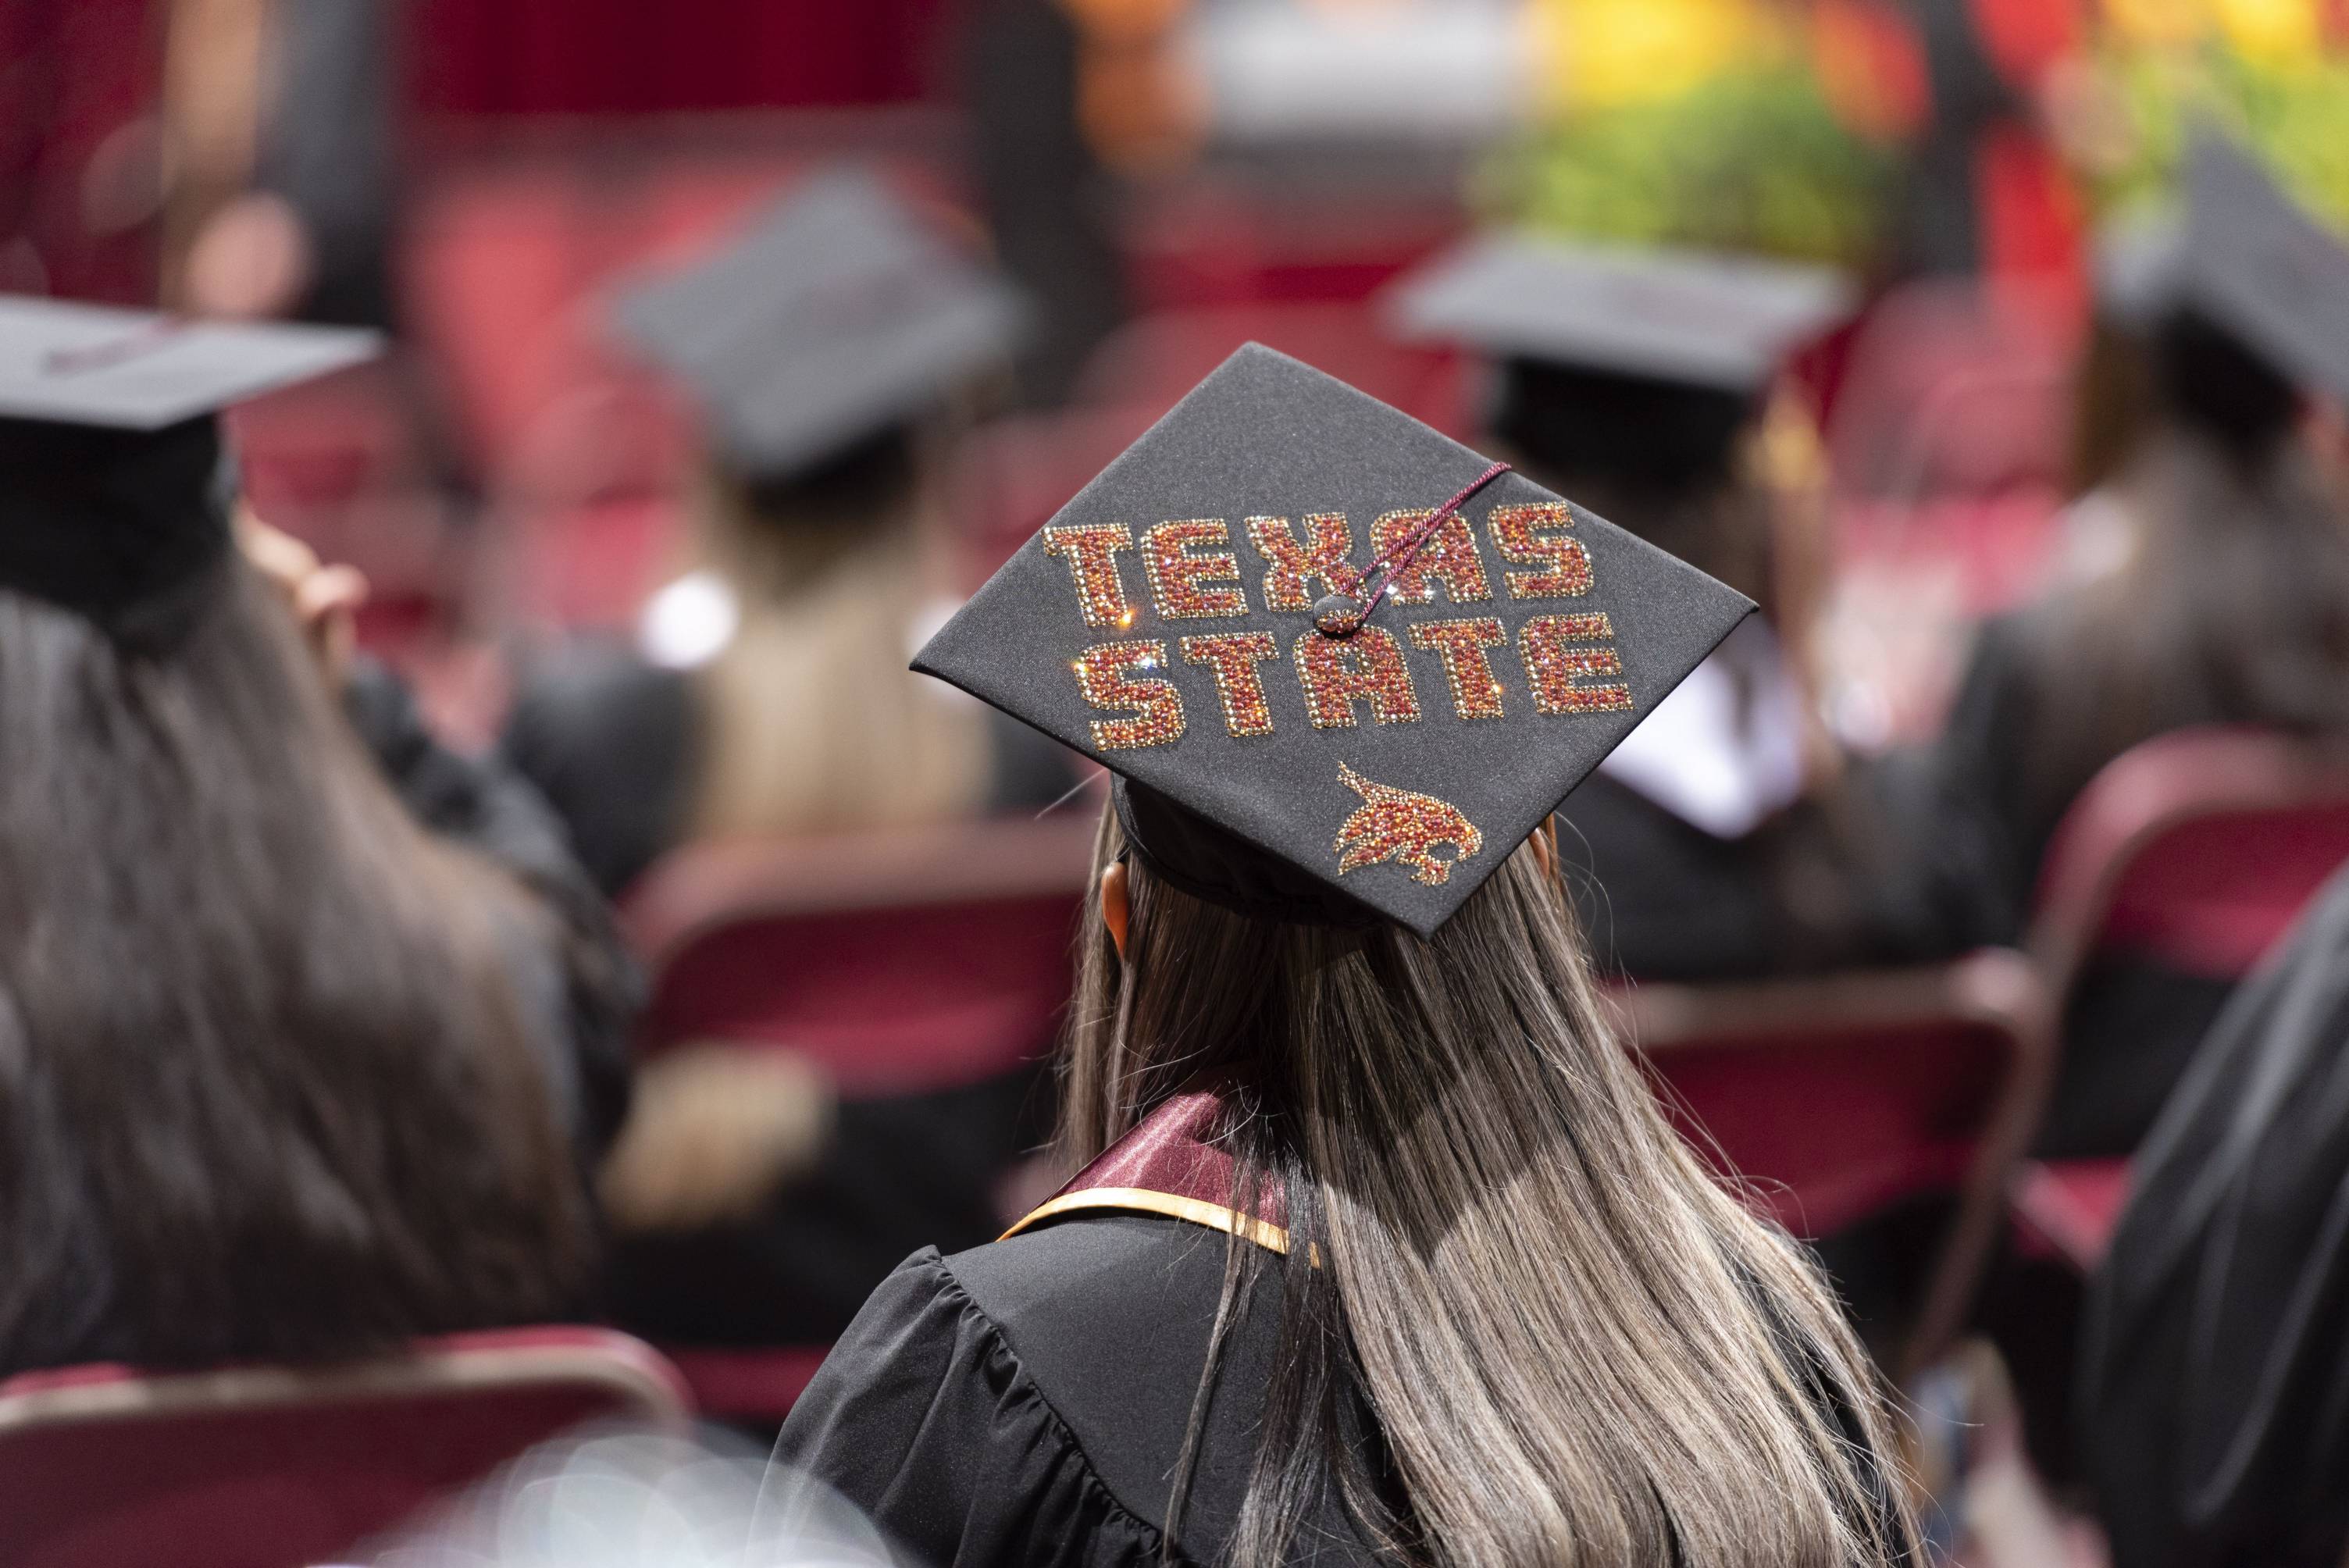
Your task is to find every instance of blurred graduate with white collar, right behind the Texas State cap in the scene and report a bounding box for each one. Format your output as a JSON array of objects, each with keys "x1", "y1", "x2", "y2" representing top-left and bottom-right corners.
[{"x1": 1391, "y1": 235, "x2": 1927, "y2": 978}]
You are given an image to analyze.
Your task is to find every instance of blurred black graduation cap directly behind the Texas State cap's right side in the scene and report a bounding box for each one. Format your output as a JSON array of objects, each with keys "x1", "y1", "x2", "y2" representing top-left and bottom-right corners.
[{"x1": 1388, "y1": 235, "x2": 1853, "y2": 483}]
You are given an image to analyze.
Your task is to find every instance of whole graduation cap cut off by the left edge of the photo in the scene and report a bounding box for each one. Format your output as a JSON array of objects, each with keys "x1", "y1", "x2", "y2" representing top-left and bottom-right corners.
[{"x1": 0, "y1": 296, "x2": 380, "y2": 648}]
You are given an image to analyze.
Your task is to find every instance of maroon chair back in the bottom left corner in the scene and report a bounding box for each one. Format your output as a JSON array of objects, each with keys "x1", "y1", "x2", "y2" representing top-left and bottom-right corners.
[{"x1": 0, "y1": 1328, "x2": 688, "y2": 1568}]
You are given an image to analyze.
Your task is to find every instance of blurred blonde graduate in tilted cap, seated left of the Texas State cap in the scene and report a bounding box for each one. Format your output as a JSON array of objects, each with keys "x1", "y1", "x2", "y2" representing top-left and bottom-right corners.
[{"x1": 503, "y1": 169, "x2": 1074, "y2": 1345}]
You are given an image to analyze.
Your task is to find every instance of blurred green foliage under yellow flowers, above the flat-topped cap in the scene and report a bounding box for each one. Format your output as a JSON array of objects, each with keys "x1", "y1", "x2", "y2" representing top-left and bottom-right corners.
[{"x1": 1475, "y1": 63, "x2": 1893, "y2": 265}]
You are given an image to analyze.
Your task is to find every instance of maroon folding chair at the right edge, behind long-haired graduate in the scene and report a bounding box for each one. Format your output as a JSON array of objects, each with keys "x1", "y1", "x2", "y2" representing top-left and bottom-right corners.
[{"x1": 2013, "y1": 728, "x2": 2349, "y2": 1270}]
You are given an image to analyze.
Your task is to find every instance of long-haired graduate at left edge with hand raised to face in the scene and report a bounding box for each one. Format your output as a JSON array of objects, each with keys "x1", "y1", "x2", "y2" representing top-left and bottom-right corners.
[{"x1": 0, "y1": 298, "x2": 634, "y2": 1376}]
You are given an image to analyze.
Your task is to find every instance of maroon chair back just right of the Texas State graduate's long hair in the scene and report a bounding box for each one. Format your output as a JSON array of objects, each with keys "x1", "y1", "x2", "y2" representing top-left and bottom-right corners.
[{"x1": 1621, "y1": 950, "x2": 2051, "y2": 1366}]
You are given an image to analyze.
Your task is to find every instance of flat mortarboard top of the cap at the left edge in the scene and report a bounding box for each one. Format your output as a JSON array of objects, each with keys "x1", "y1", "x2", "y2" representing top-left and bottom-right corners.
[{"x1": 0, "y1": 296, "x2": 383, "y2": 429}]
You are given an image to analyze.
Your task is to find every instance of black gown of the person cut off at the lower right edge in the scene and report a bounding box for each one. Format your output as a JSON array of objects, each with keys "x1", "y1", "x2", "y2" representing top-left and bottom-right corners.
[{"x1": 2079, "y1": 873, "x2": 2349, "y2": 1568}]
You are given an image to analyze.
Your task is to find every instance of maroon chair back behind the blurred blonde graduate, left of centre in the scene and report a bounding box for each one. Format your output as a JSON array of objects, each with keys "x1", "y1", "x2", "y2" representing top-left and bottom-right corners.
[{"x1": 625, "y1": 810, "x2": 1095, "y2": 1423}]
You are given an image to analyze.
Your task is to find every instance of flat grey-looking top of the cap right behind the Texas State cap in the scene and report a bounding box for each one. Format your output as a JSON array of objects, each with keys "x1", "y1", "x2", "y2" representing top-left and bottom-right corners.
[{"x1": 1388, "y1": 235, "x2": 1853, "y2": 394}]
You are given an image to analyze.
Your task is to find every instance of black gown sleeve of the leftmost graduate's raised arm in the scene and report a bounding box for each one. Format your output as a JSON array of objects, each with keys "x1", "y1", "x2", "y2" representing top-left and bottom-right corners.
[{"x1": 343, "y1": 657, "x2": 643, "y2": 1164}]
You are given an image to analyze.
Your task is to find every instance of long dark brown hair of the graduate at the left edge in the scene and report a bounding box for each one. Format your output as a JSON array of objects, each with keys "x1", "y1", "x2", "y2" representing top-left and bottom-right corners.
[{"x1": 0, "y1": 561, "x2": 594, "y2": 1370}]
